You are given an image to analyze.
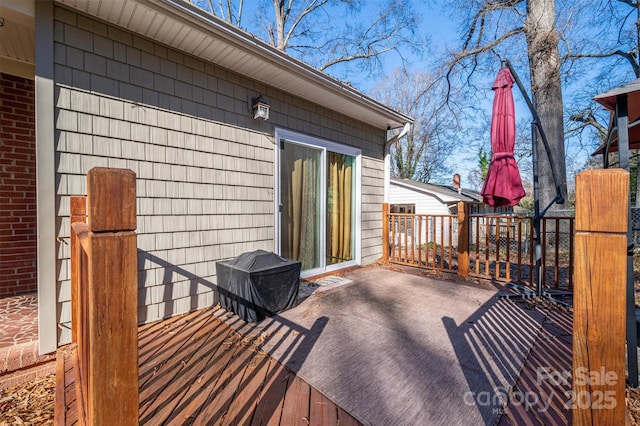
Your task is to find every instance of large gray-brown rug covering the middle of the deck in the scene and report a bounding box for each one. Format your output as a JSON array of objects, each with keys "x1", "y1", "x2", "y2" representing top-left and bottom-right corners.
[{"x1": 230, "y1": 267, "x2": 544, "y2": 425}]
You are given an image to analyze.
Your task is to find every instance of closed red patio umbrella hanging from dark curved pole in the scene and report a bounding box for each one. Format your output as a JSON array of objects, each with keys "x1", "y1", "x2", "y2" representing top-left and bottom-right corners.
[{"x1": 481, "y1": 67, "x2": 525, "y2": 207}]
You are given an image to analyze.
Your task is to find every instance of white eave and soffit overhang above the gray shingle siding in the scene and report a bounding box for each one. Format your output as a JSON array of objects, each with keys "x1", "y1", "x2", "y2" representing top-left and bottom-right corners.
[{"x1": 37, "y1": 0, "x2": 413, "y2": 129}]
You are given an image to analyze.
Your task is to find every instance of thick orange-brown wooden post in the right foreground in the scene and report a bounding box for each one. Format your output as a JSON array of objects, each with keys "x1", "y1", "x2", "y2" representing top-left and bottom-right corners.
[{"x1": 570, "y1": 169, "x2": 629, "y2": 425}]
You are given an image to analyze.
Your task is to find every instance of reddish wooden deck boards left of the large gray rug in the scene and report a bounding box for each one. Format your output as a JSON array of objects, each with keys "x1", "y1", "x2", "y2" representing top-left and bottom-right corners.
[{"x1": 56, "y1": 309, "x2": 360, "y2": 426}]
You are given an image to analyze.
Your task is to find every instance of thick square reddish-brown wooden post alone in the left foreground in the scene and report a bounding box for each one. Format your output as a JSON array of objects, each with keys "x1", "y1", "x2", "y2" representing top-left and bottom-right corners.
[{"x1": 87, "y1": 167, "x2": 138, "y2": 425}]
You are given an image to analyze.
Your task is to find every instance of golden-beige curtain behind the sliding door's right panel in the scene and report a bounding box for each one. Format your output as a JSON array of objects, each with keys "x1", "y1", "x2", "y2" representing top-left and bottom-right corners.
[{"x1": 327, "y1": 152, "x2": 354, "y2": 264}]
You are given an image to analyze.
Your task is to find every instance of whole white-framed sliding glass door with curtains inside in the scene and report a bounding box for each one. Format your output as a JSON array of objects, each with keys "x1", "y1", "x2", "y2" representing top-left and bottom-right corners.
[{"x1": 278, "y1": 132, "x2": 360, "y2": 275}]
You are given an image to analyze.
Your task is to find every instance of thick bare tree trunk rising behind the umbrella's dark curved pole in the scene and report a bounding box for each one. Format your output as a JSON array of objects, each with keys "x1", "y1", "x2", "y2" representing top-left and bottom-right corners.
[{"x1": 525, "y1": 0, "x2": 567, "y2": 210}]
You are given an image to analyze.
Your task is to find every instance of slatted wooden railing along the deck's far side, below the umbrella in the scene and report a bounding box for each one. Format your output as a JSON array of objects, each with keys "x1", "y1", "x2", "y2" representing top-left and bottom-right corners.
[{"x1": 383, "y1": 203, "x2": 574, "y2": 290}]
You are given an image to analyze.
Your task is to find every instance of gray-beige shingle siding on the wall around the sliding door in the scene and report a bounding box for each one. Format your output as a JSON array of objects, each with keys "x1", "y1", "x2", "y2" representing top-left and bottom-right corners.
[{"x1": 54, "y1": 6, "x2": 385, "y2": 343}]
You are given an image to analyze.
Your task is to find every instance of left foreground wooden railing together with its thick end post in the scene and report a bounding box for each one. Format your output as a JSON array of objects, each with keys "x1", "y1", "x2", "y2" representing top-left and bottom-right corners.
[{"x1": 71, "y1": 168, "x2": 138, "y2": 425}]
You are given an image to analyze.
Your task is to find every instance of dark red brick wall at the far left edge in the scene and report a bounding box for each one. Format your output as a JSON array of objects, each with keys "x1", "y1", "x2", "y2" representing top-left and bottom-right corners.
[{"x1": 0, "y1": 73, "x2": 37, "y2": 296}]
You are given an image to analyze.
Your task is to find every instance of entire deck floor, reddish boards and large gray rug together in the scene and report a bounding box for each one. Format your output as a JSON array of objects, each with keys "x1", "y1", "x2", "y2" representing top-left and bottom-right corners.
[{"x1": 57, "y1": 266, "x2": 572, "y2": 426}]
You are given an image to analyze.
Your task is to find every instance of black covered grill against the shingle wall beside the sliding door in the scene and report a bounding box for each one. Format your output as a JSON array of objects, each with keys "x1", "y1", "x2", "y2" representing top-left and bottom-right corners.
[{"x1": 216, "y1": 250, "x2": 301, "y2": 322}]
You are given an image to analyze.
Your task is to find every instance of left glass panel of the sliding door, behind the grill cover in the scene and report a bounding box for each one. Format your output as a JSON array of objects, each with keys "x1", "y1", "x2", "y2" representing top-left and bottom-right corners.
[{"x1": 280, "y1": 140, "x2": 322, "y2": 270}]
